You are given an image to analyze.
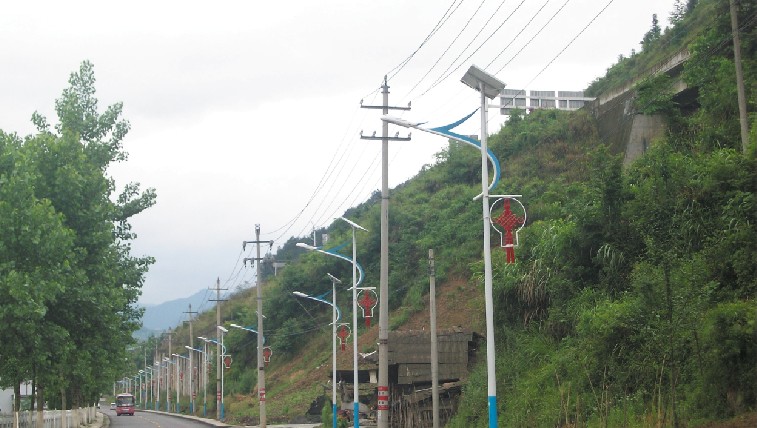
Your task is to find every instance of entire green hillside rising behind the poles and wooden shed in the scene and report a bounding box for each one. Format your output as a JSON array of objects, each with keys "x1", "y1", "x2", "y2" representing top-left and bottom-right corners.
[{"x1": 145, "y1": 0, "x2": 757, "y2": 427}]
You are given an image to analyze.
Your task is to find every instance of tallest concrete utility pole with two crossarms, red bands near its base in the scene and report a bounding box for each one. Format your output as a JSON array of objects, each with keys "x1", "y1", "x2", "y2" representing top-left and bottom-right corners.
[{"x1": 355, "y1": 76, "x2": 410, "y2": 428}]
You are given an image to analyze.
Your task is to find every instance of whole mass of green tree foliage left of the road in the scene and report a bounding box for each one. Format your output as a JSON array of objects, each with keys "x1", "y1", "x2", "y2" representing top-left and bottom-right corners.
[{"x1": 0, "y1": 62, "x2": 155, "y2": 406}]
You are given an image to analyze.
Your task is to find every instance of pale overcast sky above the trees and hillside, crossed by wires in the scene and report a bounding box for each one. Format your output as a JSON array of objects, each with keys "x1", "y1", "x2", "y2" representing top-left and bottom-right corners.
[{"x1": 0, "y1": 0, "x2": 675, "y2": 303}]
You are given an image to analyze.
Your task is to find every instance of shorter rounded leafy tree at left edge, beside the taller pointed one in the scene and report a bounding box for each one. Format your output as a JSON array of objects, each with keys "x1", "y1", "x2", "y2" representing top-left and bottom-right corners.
[{"x1": 0, "y1": 131, "x2": 77, "y2": 404}]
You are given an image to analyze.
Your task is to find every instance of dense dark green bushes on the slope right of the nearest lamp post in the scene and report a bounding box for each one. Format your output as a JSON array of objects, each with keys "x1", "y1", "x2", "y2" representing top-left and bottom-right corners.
[{"x1": 450, "y1": 1, "x2": 757, "y2": 426}]
